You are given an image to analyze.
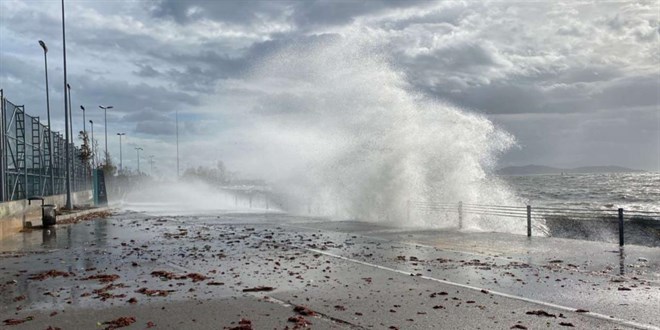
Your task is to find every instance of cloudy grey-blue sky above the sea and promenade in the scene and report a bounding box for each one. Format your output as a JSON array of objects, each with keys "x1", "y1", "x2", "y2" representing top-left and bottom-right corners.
[{"x1": 0, "y1": 0, "x2": 660, "y2": 176}]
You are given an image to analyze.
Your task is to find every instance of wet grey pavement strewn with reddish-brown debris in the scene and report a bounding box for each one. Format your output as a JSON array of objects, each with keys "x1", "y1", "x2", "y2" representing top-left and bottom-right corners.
[{"x1": 0, "y1": 211, "x2": 660, "y2": 329}]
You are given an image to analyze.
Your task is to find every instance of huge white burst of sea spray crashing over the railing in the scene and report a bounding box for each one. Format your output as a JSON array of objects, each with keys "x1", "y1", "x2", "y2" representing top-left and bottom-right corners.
[{"x1": 240, "y1": 37, "x2": 525, "y2": 232}]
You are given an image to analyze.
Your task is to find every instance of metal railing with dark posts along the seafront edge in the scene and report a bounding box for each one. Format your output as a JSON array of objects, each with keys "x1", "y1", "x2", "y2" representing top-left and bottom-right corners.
[{"x1": 407, "y1": 201, "x2": 660, "y2": 246}]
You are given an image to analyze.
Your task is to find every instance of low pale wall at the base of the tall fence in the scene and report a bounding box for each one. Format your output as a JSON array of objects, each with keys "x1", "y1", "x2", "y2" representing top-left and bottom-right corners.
[{"x1": 0, "y1": 190, "x2": 93, "y2": 239}]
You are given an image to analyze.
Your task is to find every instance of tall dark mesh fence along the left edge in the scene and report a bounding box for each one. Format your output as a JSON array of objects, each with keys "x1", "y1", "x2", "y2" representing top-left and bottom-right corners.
[{"x1": 0, "y1": 92, "x2": 92, "y2": 201}]
